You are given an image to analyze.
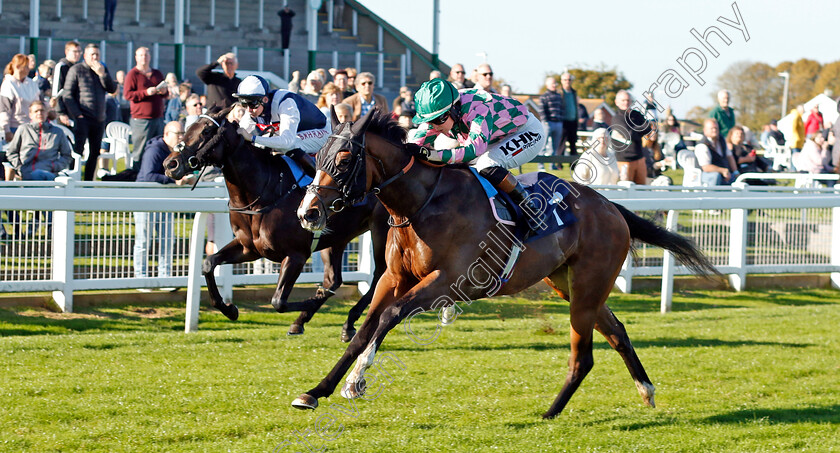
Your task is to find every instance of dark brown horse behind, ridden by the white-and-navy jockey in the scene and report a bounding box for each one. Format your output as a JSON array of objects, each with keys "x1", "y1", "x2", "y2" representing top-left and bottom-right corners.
[{"x1": 163, "y1": 109, "x2": 388, "y2": 342}]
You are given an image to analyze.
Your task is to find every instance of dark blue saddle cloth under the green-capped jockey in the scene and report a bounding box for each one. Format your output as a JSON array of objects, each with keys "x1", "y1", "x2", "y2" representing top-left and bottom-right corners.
[{"x1": 470, "y1": 167, "x2": 577, "y2": 243}]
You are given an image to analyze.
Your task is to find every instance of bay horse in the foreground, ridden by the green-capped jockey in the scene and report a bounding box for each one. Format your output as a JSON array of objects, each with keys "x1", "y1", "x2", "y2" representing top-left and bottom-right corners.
[{"x1": 292, "y1": 108, "x2": 719, "y2": 418}]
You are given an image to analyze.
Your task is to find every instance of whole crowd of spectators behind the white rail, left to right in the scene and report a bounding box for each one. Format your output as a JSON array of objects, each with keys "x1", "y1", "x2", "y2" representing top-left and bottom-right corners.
[{"x1": 6, "y1": 39, "x2": 840, "y2": 252}]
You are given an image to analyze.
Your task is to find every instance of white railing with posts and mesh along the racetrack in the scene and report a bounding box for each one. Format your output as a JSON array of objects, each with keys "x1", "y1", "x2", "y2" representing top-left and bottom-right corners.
[{"x1": 0, "y1": 180, "x2": 840, "y2": 330}]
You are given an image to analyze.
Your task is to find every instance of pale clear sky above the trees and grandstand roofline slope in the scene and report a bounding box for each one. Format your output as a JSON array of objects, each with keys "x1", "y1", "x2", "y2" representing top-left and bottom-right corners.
[{"x1": 361, "y1": 0, "x2": 840, "y2": 117}]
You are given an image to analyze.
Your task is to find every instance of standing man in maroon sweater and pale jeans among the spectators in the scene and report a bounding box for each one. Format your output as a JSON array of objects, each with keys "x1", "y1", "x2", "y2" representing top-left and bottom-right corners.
[{"x1": 123, "y1": 47, "x2": 169, "y2": 170}]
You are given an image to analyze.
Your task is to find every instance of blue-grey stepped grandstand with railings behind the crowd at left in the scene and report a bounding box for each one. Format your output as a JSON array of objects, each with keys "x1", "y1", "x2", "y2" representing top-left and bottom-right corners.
[{"x1": 0, "y1": 0, "x2": 449, "y2": 97}]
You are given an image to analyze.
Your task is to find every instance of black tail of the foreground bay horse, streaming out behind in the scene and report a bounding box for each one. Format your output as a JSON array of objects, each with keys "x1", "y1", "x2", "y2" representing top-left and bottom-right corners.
[{"x1": 613, "y1": 203, "x2": 722, "y2": 277}]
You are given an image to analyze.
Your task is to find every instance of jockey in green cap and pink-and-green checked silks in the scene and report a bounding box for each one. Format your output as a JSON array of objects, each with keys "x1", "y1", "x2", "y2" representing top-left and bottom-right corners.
[{"x1": 409, "y1": 79, "x2": 546, "y2": 232}]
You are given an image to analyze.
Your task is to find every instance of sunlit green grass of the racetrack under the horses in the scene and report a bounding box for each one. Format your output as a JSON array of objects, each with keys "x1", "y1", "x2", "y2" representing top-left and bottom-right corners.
[{"x1": 0, "y1": 289, "x2": 840, "y2": 452}]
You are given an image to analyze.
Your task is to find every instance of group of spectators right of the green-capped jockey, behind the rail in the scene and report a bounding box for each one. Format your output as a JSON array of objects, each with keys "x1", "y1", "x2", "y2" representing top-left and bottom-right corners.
[{"x1": 564, "y1": 81, "x2": 840, "y2": 185}]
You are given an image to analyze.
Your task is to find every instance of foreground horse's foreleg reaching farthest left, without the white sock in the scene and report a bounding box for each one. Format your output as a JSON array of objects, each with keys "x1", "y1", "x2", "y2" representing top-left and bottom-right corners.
[{"x1": 292, "y1": 271, "x2": 410, "y2": 409}]
